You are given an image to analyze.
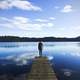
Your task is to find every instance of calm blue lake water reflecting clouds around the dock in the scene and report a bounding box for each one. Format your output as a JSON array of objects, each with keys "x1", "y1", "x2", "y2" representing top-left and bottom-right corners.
[{"x1": 0, "y1": 42, "x2": 80, "y2": 80}]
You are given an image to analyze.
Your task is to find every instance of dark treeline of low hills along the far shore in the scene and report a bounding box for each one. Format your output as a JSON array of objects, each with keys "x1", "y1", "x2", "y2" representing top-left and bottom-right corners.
[{"x1": 0, "y1": 36, "x2": 80, "y2": 42}]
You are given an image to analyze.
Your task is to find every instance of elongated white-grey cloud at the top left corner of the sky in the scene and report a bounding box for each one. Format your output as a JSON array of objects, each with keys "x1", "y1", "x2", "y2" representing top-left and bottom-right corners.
[{"x1": 0, "y1": 0, "x2": 42, "y2": 11}]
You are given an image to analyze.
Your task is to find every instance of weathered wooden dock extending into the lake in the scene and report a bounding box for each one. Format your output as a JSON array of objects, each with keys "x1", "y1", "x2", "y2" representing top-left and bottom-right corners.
[{"x1": 27, "y1": 57, "x2": 57, "y2": 80}]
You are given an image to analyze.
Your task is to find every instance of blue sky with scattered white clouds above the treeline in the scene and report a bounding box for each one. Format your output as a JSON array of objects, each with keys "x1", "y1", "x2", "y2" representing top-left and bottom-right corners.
[{"x1": 0, "y1": 0, "x2": 80, "y2": 37}]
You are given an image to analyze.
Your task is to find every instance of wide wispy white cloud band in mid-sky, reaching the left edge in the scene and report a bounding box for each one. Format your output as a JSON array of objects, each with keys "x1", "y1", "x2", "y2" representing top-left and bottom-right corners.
[{"x1": 0, "y1": 16, "x2": 54, "y2": 31}]
